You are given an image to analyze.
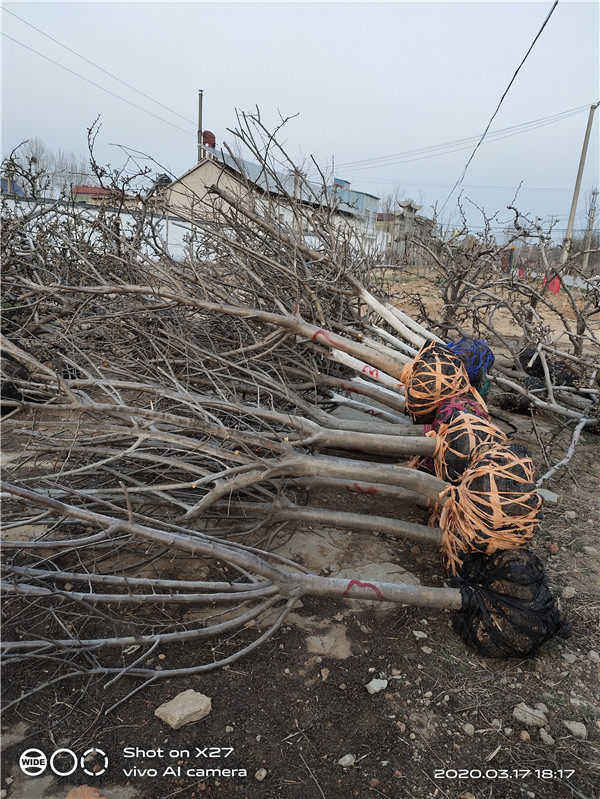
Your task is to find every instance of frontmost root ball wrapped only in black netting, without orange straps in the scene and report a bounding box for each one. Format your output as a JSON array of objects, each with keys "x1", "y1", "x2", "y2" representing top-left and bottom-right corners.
[{"x1": 452, "y1": 549, "x2": 571, "y2": 658}]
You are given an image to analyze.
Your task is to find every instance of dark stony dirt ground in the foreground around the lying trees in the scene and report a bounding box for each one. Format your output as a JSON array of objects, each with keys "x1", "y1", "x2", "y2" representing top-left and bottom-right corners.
[{"x1": 1, "y1": 406, "x2": 600, "y2": 799}]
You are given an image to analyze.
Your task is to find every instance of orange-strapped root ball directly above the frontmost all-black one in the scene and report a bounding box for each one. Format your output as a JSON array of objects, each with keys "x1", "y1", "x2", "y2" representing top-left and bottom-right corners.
[{"x1": 429, "y1": 444, "x2": 542, "y2": 574}]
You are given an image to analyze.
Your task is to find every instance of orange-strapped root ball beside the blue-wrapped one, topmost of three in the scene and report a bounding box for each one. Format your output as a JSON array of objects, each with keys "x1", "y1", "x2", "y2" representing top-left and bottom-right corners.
[{"x1": 400, "y1": 341, "x2": 486, "y2": 422}]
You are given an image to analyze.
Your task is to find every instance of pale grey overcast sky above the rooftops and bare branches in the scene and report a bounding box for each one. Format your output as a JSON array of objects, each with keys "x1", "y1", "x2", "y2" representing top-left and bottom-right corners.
[{"x1": 2, "y1": 0, "x2": 600, "y2": 234}]
